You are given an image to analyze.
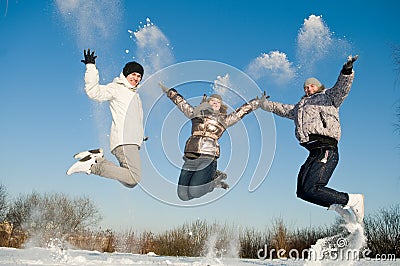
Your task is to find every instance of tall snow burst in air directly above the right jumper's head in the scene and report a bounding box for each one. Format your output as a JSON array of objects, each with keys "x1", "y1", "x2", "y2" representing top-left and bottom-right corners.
[{"x1": 297, "y1": 15, "x2": 333, "y2": 70}]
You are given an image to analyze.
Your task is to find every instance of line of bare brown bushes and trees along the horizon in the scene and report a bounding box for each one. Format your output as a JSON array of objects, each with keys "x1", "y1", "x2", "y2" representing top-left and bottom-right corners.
[{"x1": 0, "y1": 185, "x2": 400, "y2": 258}]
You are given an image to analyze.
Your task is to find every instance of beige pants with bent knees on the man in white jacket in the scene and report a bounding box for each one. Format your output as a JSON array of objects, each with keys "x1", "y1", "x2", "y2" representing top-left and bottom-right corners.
[{"x1": 90, "y1": 145, "x2": 142, "y2": 188}]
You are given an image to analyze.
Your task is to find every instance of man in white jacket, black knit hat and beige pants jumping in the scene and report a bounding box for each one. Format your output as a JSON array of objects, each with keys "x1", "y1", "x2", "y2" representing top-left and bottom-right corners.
[{"x1": 67, "y1": 49, "x2": 144, "y2": 188}]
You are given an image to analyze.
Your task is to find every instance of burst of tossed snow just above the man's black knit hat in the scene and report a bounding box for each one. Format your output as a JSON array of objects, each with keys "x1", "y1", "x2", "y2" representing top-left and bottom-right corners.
[{"x1": 128, "y1": 18, "x2": 174, "y2": 78}]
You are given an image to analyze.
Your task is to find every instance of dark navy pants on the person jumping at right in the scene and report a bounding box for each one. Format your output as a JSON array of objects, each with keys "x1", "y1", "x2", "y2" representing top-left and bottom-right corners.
[{"x1": 297, "y1": 146, "x2": 349, "y2": 207}]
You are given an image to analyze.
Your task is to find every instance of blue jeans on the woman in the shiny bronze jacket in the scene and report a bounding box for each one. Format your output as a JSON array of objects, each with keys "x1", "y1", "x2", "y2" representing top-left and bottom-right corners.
[{"x1": 178, "y1": 158, "x2": 217, "y2": 201}]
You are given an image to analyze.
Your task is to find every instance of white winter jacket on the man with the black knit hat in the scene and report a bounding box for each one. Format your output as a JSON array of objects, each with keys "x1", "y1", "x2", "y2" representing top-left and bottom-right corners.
[{"x1": 85, "y1": 64, "x2": 144, "y2": 150}]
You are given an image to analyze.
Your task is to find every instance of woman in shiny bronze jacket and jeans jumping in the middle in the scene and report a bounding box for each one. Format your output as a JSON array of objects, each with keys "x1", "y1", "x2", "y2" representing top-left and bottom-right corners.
[{"x1": 160, "y1": 83, "x2": 260, "y2": 201}]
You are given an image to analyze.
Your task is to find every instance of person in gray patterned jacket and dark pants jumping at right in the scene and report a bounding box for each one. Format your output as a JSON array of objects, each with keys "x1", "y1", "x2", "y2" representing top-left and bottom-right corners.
[{"x1": 261, "y1": 56, "x2": 364, "y2": 223}]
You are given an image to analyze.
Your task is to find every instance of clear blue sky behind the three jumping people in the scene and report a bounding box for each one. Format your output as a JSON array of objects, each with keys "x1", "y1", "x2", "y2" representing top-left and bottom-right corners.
[{"x1": 0, "y1": 0, "x2": 400, "y2": 231}]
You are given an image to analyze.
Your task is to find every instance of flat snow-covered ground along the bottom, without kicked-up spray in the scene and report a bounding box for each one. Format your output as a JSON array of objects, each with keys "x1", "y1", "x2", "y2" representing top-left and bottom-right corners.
[{"x1": 0, "y1": 248, "x2": 394, "y2": 266}]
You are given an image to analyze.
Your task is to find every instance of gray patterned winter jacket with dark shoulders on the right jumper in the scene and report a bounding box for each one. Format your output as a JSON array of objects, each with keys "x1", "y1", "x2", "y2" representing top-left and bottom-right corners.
[{"x1": 261, "y1": 71, "x2": 354, "y2": 143}]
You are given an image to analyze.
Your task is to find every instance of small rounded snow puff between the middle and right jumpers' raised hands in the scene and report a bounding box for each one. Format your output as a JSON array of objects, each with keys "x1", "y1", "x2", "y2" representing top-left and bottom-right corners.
[{"x1": 246, "y1": 51, "x2": 296, "y2": 84}]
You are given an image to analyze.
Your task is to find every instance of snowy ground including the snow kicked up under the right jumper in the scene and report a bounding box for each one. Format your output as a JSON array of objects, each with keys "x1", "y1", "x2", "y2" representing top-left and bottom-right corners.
[{"x1": 0, "y1": 218, "x2": 394, "y2": 266}]
